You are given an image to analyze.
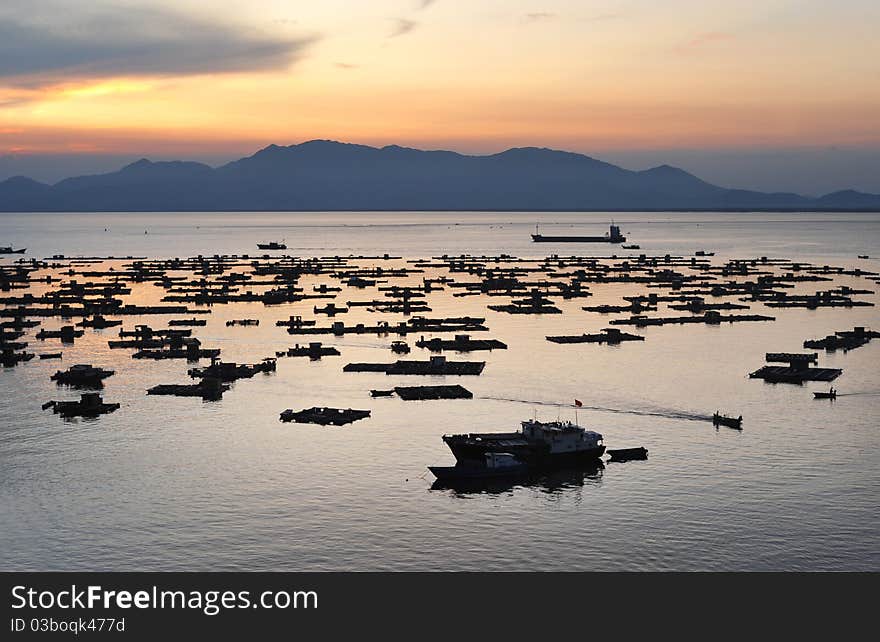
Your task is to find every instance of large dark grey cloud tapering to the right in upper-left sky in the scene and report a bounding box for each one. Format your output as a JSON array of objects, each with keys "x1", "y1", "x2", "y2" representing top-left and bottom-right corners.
[{"x1": 0, "y1": 0, "x2": 315, "y2": 85}]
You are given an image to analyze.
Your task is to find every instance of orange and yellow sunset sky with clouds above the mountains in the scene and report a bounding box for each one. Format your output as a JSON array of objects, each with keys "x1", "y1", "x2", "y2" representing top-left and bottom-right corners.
[{"x1": 0, "y1": 0, "x2": 880, "y2": 191}]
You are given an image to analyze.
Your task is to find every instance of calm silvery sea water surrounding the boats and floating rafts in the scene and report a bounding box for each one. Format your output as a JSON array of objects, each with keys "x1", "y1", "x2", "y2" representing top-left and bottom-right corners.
[{"x1": 0, "y1": 212, "x2": 880, "y2": 571}]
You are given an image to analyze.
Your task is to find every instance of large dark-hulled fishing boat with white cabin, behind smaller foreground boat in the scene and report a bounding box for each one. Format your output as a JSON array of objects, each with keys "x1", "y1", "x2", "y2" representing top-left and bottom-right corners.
[{"x1": 443, "y1": 420, "x2": 605, "y2": 468}]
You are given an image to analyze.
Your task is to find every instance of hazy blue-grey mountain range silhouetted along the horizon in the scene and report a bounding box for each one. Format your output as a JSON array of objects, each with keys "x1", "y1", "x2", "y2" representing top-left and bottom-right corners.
[{"x1": 0, "y1": 140, "x2": 880, "y2": 212}]
